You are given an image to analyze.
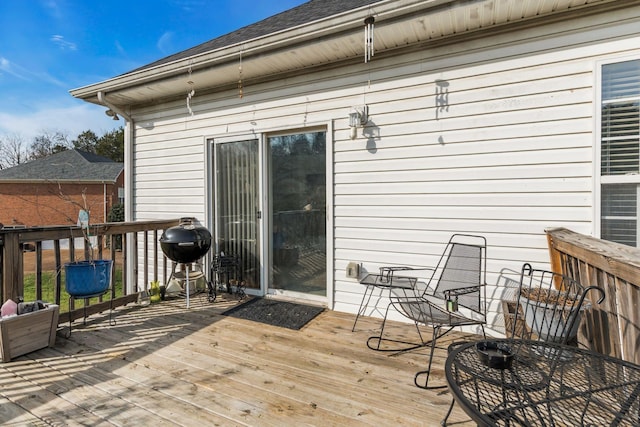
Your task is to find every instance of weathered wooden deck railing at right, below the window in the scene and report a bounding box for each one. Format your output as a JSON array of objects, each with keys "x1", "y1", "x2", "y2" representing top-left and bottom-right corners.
[{"x1": 546, "y1": 228, "x2": 640, "y2": 364}]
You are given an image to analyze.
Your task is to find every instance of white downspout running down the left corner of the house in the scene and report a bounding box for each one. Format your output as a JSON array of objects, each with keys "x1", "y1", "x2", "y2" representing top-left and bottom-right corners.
[{"x1": 97, "y1": 91, "x2": 138, "y2": 293}]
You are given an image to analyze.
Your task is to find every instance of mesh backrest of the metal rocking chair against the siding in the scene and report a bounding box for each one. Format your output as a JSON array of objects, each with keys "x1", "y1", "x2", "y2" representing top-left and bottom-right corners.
[{"x1": 427, "y1": 234, "x2": 487, "y2": 312}]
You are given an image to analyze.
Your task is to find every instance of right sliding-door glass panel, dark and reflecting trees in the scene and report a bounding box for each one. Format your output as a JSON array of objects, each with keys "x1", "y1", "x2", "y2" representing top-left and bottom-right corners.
[{"x1": 267, "y1": 132, "x2": 327, "y2": 296}]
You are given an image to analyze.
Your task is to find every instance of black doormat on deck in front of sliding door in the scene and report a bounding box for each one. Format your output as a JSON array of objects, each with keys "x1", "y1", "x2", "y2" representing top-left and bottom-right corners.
[{"x1": 223, "y1": 298, "x2": 324, "y2": 330}]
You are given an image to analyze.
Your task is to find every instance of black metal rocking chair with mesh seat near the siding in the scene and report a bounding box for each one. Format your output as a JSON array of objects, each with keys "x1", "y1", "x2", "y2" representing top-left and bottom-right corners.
[{"x1": 367, "y1": 234, "x2": 487, "y2": 389}]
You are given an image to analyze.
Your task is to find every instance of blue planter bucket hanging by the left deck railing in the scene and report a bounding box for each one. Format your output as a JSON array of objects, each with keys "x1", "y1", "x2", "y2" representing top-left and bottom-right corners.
[{"x1": 64, "y1": 259, "x2": 113, "y2": 298}]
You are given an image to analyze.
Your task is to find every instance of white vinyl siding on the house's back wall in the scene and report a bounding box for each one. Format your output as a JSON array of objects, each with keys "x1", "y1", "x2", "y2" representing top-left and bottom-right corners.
[{"x1": 133, "y1": 7, "x2": 640, "y2": 336}]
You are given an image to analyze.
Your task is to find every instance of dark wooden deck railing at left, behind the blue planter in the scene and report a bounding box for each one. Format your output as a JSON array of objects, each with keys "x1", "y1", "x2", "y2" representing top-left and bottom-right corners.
[{"x1": 0, "y1": 219, "x2": 179, "y2": 323}]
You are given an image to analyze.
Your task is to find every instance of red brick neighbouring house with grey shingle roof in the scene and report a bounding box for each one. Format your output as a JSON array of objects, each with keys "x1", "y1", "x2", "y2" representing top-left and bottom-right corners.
[{"x1": 0, "y1": 150, "x2": 124, "y2": 227}]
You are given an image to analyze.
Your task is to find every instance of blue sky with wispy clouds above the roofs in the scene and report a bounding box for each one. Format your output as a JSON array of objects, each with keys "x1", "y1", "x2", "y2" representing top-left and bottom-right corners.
[{"x1": 0, "y1": 0, "x2": 306, "y2": 145}]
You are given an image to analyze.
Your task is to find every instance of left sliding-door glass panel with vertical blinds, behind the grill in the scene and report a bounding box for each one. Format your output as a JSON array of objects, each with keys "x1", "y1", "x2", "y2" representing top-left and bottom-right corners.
[{"x1": 214, "y1": 140, "x2": 260, "y2": 289}]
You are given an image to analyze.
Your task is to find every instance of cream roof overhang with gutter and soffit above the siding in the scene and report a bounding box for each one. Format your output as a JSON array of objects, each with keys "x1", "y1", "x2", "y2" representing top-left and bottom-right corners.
[{"x1": 71, "y1": 0, "x2": 626, "y2": 107}]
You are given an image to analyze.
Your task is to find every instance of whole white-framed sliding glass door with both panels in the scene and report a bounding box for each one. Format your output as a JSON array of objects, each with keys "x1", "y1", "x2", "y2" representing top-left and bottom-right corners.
[{"x1": 212, "y1": 131, "x2": 327, "y2": 299}]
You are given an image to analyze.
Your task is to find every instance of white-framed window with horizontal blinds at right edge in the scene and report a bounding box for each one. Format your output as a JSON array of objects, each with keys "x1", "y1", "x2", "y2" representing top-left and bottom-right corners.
[{"x1": 600, "y1": 60, "x2": 640, "y2": 246}]
